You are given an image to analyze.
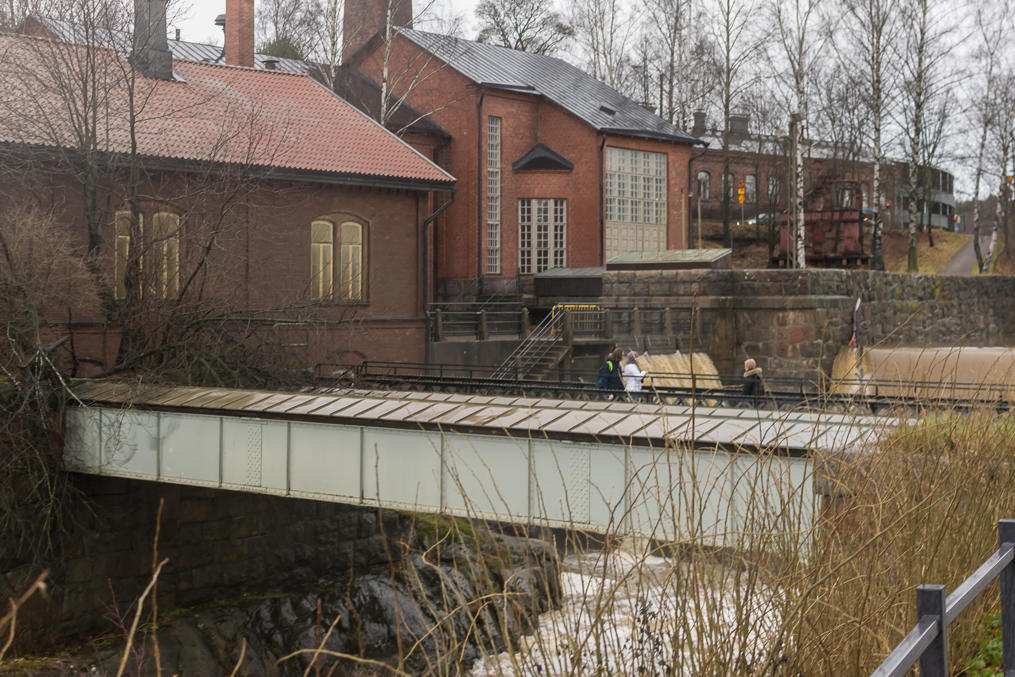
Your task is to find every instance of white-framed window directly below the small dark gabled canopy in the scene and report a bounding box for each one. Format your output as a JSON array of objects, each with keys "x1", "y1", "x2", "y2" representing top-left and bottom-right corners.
[{"x1": 518, "y1": 198, "x2": 567, "y2": 275}]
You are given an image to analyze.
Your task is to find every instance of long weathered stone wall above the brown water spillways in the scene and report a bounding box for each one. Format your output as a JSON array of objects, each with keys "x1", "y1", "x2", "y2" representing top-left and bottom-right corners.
[{"x1": 602, "y1": 270, "x2": 1015, "y2": 377}]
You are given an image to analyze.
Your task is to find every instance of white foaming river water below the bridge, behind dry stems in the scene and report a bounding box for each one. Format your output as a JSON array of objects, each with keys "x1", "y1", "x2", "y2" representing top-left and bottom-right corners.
[{"x1": 471, "y1": 551, "x2": 780, "y2": 677}]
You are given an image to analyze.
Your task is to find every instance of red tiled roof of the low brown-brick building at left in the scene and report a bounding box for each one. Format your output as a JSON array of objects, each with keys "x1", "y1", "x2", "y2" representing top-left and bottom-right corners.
[{"x1": 0, "y1": 36, "x2": 454, "y2": 184}]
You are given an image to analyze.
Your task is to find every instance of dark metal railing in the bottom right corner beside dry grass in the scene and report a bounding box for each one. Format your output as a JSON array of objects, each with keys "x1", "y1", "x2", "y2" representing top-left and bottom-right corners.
[{"x1": 872, "y1": 520, "x2": 1015, "y2": 677}]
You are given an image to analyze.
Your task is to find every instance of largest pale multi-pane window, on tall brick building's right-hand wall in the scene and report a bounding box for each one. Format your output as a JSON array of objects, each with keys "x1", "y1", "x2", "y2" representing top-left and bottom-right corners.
[{"x1": 605, "y1": 146, "x2": 667, "y2": 258}]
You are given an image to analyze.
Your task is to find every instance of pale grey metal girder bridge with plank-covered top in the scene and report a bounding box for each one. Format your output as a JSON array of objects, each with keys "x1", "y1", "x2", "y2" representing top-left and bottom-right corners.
[{"x1": 65, "y1": 382, "x2": 900, "y2": 545}]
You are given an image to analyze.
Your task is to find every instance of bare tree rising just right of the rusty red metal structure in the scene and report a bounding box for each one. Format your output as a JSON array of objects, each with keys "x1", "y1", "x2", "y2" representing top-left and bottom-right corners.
[{"x1": 845, "y1": 0, "x2": 899, "y2": 270}]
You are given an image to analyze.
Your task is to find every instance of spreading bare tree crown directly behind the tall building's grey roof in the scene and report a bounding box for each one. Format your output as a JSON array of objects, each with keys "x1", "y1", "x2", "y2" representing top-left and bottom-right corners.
[{"x1": 476, "y1": 0, "x2": 574, "y2": 55}]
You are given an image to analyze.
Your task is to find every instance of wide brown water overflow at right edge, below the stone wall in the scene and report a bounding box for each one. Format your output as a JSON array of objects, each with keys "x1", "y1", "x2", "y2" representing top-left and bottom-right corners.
[{"x1": 832, "y1": 346, "x2": 1015, "y2": 400}]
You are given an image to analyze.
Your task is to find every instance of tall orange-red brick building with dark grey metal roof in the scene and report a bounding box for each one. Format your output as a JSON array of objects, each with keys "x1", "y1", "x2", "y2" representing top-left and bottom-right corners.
[{"x1": 343, "y1": 0, "x2": 697, "y2": 299}]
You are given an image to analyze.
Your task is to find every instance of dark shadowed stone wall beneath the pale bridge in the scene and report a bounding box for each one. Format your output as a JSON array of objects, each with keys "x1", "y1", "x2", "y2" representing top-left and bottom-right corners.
[{"x1": 0, "y1": 475, "x2": 558, "y2": 661}]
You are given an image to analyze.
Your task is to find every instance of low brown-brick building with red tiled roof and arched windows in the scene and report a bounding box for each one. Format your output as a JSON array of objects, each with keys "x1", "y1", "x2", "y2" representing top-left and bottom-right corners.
[{"x1": 0, "y1": 0, "x2": 454, "y2": 367}]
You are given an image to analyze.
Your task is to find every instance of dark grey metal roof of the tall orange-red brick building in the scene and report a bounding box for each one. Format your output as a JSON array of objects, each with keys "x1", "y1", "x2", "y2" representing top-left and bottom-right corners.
[{"x1": 398, "y1": 28, "x2": 698, "y2": 143}]
